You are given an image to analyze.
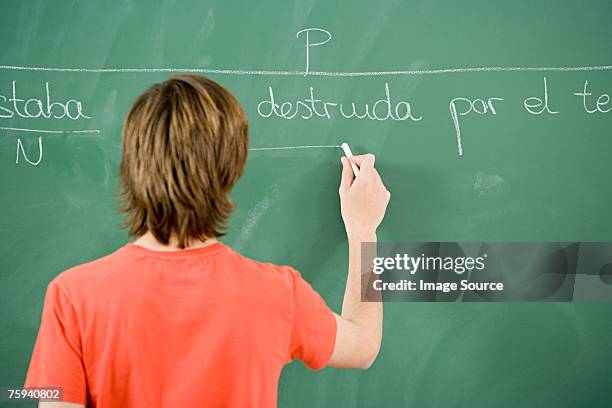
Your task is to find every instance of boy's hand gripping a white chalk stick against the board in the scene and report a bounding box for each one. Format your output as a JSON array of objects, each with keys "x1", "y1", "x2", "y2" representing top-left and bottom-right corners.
[{"x1": 339, "y1": 154, "x2": 391, "y2": 239}]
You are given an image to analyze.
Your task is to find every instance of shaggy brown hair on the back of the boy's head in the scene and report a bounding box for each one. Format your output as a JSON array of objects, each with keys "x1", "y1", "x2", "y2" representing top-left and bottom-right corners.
[{"x1": 119, "y1": 75, "x2": 249, "y2": 248}]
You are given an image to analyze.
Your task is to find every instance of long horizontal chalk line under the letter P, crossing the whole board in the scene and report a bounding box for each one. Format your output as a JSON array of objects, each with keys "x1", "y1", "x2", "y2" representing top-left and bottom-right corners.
[{"x1": 0, "y1": 65, "x2": 612, "y2": 77}]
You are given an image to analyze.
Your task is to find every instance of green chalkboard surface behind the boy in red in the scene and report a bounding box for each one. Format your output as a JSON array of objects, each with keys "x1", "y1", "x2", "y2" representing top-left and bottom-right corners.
[{"x1": 0, "y1": 0, "x2": 612, "y2": 407}]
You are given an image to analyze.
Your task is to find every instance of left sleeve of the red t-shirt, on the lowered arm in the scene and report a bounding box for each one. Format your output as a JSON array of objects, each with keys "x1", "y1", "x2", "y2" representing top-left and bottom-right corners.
[{"x1": 25, "y1": 282, "x2": 87, "y2": 404}]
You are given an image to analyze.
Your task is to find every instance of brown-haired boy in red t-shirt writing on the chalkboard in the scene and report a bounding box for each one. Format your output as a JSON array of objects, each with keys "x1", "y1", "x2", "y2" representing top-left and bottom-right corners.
[{"x1": 26, "y1": 75, "x2": 390, "y2": 408}]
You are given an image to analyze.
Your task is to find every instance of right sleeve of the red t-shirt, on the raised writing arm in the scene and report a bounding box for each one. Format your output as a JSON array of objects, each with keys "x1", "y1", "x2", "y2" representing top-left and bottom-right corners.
[{"x1": 289, "y1": 269, "x2": 336, "y2": 370}]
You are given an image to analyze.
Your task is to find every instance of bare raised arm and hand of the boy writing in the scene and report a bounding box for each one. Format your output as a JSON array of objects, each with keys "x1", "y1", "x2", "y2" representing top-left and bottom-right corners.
[{"x1": 327, "y1": 154, "x2": 391, "y2": 370}]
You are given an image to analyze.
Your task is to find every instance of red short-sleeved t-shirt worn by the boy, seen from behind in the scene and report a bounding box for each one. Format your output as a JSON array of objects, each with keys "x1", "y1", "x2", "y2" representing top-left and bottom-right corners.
[{"x1": 26, "y1": 243, "x2": 336, "y2": 408}]
